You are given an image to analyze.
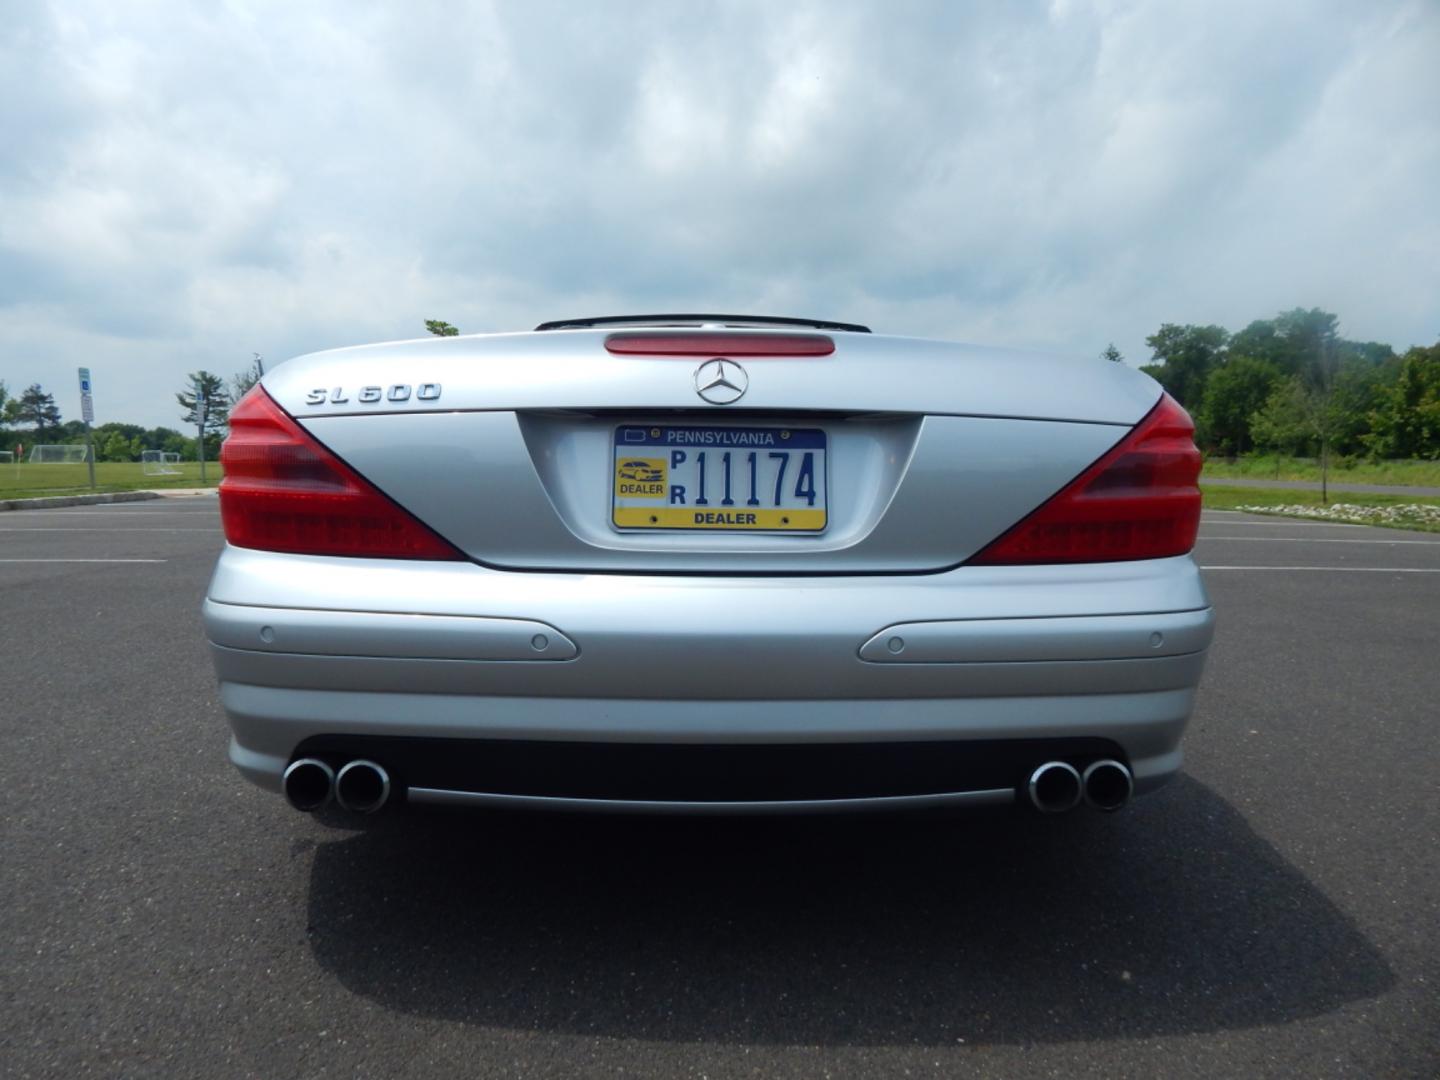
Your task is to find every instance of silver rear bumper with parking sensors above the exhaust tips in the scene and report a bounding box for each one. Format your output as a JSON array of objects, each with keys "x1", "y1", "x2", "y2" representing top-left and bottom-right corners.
[{"x1": 204, "y1": 549, "x2": 1212, "y2": 809}]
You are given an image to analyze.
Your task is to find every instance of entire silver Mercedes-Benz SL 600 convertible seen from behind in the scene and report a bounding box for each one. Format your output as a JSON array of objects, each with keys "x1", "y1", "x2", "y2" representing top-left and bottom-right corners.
[{"x1": 204, "y1": 315, "x2": 1214, "y2": 814}]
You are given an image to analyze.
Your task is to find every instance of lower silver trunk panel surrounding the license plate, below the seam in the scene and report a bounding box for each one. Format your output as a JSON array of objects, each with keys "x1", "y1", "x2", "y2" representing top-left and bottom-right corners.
[{"x1": 305, "y1": 412, "x2": 1128, "y2": 573}]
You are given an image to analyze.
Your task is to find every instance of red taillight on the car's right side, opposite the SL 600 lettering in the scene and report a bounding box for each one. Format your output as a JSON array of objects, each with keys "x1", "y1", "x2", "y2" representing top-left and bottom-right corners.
[{"x1": 969, "y1": 395, "x2": 1201, "y2": 566}]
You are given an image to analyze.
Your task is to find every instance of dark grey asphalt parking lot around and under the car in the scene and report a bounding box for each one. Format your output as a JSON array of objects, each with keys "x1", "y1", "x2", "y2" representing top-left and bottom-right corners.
[{"x1": 0, "y1": 497, "x2": 1440, "y2": 1080}]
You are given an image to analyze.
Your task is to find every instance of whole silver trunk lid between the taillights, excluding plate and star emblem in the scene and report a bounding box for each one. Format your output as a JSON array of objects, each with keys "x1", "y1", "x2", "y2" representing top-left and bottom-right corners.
[{"x1": 264, "y1": 330, "x2": 1159, "y2": 575}]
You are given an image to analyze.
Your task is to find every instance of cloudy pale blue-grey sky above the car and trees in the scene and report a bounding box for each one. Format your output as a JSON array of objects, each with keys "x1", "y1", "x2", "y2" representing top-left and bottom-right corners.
[{"x1": 0, "y1": 0, "x2": 1440, "y2": 426}]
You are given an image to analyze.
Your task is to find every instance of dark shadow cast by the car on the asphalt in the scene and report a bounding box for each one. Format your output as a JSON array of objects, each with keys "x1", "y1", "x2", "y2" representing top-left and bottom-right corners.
[{"x1": 298, "y1": 778, "x2": 1394, "y2": 1045}]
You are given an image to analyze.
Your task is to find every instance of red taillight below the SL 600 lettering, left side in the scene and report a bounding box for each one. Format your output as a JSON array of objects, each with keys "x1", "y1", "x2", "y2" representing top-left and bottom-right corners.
[{"x1": 220, "y1": 386, "x2": 465, "y2": 559}]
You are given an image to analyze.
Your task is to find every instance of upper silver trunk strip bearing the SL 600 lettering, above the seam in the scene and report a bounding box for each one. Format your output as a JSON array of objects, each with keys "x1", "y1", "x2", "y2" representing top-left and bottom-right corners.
[{"x1": 264, "y1": 330, "x2": 1159, "y2": 426}]
